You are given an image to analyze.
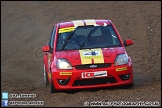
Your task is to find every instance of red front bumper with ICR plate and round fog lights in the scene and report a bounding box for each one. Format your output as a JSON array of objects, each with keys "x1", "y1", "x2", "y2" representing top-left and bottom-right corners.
[{"x1": 52, "y1": 64, "x2": 133, "y2": 90}]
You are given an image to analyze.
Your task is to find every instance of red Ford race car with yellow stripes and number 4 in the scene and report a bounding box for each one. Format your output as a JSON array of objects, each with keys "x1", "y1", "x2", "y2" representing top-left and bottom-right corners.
[{"x1": 42, "y1": 19, "x2": 133, "y2": 93}]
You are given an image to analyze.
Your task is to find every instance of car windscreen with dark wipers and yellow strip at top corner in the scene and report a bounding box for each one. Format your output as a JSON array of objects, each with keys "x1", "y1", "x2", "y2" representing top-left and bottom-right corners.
[{"x1": 56, "y1": 25, "x2": 121, "y2": 51}]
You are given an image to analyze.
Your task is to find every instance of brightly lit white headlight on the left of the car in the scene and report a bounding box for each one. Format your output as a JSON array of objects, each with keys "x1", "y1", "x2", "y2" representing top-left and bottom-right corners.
[{"x1": 57, "y1": 59, "x2": 72, "y2": 69}]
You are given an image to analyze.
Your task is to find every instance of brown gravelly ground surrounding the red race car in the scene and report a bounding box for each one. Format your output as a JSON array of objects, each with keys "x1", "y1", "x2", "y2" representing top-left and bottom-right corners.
[{"x1": 1, "y1": 1, "x2": 161, "y2": 107}]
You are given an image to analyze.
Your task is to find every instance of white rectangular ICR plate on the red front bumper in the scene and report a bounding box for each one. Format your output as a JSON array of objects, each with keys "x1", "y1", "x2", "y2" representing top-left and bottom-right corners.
[{"x1": 81, "y1": 71, "x2": 107, "y2": 78}]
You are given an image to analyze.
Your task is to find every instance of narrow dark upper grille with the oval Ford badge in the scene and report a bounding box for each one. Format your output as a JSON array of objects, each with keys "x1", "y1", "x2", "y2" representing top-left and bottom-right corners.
[{"x1": 75, "y1": 63, "x2": 111, "y2": 70}]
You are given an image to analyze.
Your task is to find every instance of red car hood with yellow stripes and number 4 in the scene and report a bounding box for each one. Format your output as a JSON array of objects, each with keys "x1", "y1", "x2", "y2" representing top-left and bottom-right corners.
[{"x1": 56, "y1": 47, "x2": 125, "y2": 66}]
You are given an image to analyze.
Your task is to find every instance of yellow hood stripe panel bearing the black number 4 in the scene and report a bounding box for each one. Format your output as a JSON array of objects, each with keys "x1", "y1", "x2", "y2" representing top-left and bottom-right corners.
[{"x1": 79, "y1": 48, "x2": 104, "y2": 64}]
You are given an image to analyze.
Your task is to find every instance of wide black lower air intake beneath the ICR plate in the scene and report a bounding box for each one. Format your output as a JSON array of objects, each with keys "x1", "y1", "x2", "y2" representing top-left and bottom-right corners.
[{"x1": 73, "y1": 77, "x2": 117, "y2": 86}]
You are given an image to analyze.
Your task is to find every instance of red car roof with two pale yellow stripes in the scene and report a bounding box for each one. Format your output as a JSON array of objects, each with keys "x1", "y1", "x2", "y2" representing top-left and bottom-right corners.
[{"x1": 59, "y1": 19, "x2": 111, "y2": 28}]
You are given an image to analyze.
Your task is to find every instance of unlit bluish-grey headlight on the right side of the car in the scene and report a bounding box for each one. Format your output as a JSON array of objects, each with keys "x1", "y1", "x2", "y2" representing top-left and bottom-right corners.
[{"x1": 114, "y1": 54, "x2": 128, "y2": 66}]
